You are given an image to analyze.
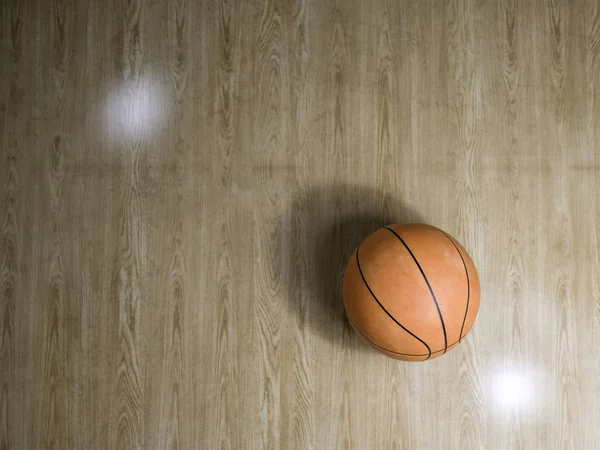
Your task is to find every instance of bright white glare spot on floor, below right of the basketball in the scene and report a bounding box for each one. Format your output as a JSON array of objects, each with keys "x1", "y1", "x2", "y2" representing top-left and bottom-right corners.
[{"x1": 493, "y1": 370, "x2": 536, "y2": 410}]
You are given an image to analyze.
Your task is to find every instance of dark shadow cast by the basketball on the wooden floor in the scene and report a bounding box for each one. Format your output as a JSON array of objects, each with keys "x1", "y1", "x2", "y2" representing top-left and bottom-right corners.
[{"x1": 288, "y1": 185, "x2": 422, "y2": 352}]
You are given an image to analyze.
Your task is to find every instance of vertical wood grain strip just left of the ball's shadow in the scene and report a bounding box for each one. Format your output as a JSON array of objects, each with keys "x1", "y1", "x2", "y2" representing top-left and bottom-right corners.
[{"x1": 250, "y1": 0, "x2": 287, "y2": 449}]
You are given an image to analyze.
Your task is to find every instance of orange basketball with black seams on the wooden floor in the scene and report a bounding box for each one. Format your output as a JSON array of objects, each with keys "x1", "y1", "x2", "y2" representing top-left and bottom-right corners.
[{"x1": 343, "y1": 224, "x2": 479, "y2": 361}]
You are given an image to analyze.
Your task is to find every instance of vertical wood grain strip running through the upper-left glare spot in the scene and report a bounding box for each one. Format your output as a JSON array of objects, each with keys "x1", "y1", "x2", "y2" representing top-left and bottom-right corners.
[{"x1": 111, "y1": 0, "x2": 147, "y2": 449}]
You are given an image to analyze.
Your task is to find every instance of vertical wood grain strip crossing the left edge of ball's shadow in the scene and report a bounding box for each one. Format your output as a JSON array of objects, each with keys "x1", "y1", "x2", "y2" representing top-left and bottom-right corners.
[{"x1": 283, "y1": 0, "x2": 316, "y2": 449}]
